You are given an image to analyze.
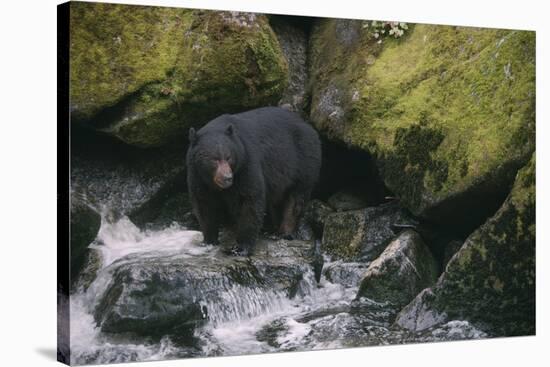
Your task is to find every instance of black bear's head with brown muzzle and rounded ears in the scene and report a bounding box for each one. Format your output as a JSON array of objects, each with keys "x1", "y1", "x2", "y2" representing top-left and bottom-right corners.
[{"x1": 189, "y1": 124, "x2": 244, "y2": 190}]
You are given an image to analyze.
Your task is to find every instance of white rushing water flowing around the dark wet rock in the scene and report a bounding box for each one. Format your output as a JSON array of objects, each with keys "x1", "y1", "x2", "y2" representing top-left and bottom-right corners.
[{"x1": 70, "y1": 217, "x2": 492, "y2": 364}]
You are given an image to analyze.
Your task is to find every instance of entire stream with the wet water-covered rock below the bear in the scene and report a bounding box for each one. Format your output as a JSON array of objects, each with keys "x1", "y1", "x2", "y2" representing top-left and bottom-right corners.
[{"x1": 70, "y1": 215, "x2": 488, "y2": 364}]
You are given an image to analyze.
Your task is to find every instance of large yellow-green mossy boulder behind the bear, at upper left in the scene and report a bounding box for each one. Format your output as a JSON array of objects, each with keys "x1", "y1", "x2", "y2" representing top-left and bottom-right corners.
[{"x1": 70, "y1": 2, "x2": 288, "y2": 147}]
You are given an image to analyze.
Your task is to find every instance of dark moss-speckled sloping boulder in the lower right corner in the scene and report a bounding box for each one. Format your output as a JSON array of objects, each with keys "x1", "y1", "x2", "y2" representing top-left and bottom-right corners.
[{"x1": 396, "y1": 155, "x2": 535, "y2": 335}]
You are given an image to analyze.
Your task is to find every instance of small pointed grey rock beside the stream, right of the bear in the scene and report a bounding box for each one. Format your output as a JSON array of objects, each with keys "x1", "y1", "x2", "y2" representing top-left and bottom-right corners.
[{"x1": 357, "y1": 230, "x2": 438, "y2": 307}]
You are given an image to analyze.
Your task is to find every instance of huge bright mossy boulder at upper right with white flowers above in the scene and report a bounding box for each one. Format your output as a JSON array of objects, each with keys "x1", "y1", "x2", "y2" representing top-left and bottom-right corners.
[{"x1": 310, "y1": 19, "x2": 535, "y2": 229}]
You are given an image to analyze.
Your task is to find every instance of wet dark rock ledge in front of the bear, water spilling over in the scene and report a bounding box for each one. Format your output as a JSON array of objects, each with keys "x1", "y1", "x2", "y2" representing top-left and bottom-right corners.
[{"x1": 95, "y1": 240, "x2": 320, "y2": 339}]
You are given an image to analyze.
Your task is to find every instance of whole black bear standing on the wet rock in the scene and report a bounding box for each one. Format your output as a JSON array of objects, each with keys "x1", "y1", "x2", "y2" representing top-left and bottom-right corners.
[{"x1": 187, "y1": 107, "x2": 321, "y2": 255}]
